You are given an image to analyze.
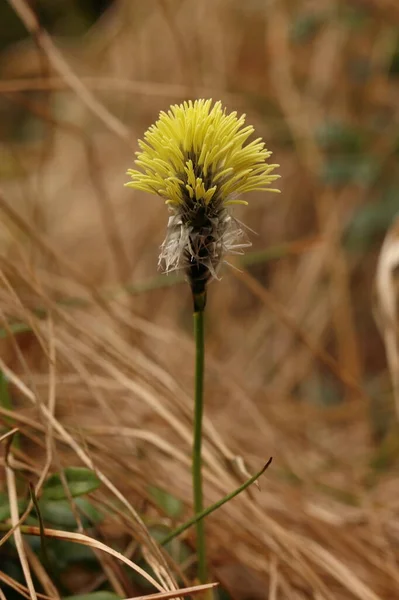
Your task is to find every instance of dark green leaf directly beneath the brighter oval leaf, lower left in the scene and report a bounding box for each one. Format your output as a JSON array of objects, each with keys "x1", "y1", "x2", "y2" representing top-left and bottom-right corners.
[{"x1": 39, "y1": 498, "x2": 103, "y2": 528}]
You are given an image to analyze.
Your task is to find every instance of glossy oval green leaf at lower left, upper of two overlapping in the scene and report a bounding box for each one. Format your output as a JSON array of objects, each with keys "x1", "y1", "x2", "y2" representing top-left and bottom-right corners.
[{"x1": 41, "y1": 467, "x2": 101, "y2": 500}]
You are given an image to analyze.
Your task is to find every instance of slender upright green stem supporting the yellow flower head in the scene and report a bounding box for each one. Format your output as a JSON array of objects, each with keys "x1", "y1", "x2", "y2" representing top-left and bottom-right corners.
[{"x1": 192, "y1": 294, "x2": 207, "y2": 583}]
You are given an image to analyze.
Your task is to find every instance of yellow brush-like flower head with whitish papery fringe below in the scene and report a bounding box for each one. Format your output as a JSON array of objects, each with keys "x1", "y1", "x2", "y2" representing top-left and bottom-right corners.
[{"x1": 126, "y1": 100, "x2": 279, "y2": 280}]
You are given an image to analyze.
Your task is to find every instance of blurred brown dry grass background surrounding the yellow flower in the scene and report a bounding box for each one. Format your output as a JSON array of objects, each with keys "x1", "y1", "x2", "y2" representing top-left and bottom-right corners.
[{"x1": 0, "y1": 0, "x2": 399, "y2": 600}]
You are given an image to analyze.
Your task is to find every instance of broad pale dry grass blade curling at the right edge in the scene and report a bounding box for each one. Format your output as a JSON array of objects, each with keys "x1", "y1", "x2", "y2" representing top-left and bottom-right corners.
[{"x1": 375, "y1": 213, "x2": 399, "y2": 420}]
